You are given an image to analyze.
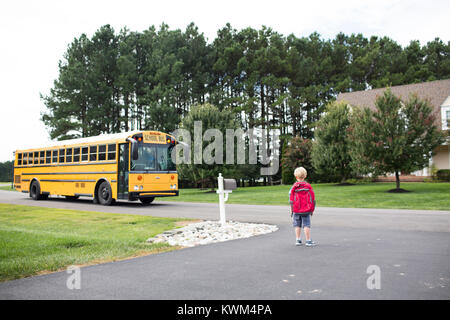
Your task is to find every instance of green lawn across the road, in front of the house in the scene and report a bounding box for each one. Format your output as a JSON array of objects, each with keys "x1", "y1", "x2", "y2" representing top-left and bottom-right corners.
[{"x1": 162, "y1": 182, "x2": 450, "y2": 210}]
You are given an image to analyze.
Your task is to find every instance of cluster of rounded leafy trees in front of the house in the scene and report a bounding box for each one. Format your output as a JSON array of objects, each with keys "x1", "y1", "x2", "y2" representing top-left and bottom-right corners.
[{"x1": 282, "y1": 88, "x2": 448, "y2": 192}]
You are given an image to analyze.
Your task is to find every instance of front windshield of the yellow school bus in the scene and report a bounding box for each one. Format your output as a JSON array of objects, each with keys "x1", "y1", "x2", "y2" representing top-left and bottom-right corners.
[{"x1": 131, "y1": 142, "x2": 176, "y2": 172}]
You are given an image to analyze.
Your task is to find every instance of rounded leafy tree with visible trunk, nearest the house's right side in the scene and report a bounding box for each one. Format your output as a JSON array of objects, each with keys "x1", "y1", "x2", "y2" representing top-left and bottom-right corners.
[{"x1": 349, "y1": 89, "x2": 444, "y2": 191}]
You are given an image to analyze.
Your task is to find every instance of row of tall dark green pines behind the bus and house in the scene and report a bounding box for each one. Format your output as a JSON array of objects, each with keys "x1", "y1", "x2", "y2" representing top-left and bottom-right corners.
[{"x1": 41, "y1": 23, "x2": 450, "y2": 140}]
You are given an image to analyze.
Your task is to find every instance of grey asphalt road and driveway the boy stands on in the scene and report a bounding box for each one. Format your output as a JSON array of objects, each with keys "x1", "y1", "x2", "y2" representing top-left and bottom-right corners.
[{"x1": 0, "y1": 191, "x2": 450, "y2": 300}]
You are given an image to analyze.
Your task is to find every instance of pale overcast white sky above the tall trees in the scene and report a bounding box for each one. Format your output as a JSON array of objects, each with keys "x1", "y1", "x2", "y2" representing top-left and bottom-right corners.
[{"x1": 0, "y1": 0, "x2": 450, "y2": 161}]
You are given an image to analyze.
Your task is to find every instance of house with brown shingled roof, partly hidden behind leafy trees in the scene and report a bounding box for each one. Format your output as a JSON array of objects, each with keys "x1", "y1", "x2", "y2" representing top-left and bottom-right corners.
[{"x1": 337, "y1": 79, "x2": 450, "y2": 181}]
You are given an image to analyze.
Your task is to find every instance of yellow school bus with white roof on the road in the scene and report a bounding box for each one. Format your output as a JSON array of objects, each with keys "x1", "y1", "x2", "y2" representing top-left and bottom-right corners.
[{"x1": 14, "y1": 131, "x2": 178, "y2": 205}]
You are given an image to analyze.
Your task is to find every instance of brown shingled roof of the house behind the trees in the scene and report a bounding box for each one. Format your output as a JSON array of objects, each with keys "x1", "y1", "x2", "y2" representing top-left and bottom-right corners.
[{"x1": 337, "y1": 79, "x2": 450, "y2": 129}]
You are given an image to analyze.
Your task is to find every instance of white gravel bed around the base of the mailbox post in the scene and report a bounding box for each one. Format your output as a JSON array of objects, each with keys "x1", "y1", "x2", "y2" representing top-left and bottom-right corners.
[{"x1": 147, "y1": 221, "x2": 278, "y2": 247}]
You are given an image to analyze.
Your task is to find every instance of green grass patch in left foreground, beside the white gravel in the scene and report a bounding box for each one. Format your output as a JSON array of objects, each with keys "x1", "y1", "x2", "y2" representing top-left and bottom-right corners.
[{"x1": 0, "y1": 204, "x2": 191, "y2": 281}]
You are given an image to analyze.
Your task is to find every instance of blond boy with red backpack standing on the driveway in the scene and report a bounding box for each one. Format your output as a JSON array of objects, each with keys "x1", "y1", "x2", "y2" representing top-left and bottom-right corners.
[{"x1": 289, "y1": 167, "x2": 316, "y2": 247}]
